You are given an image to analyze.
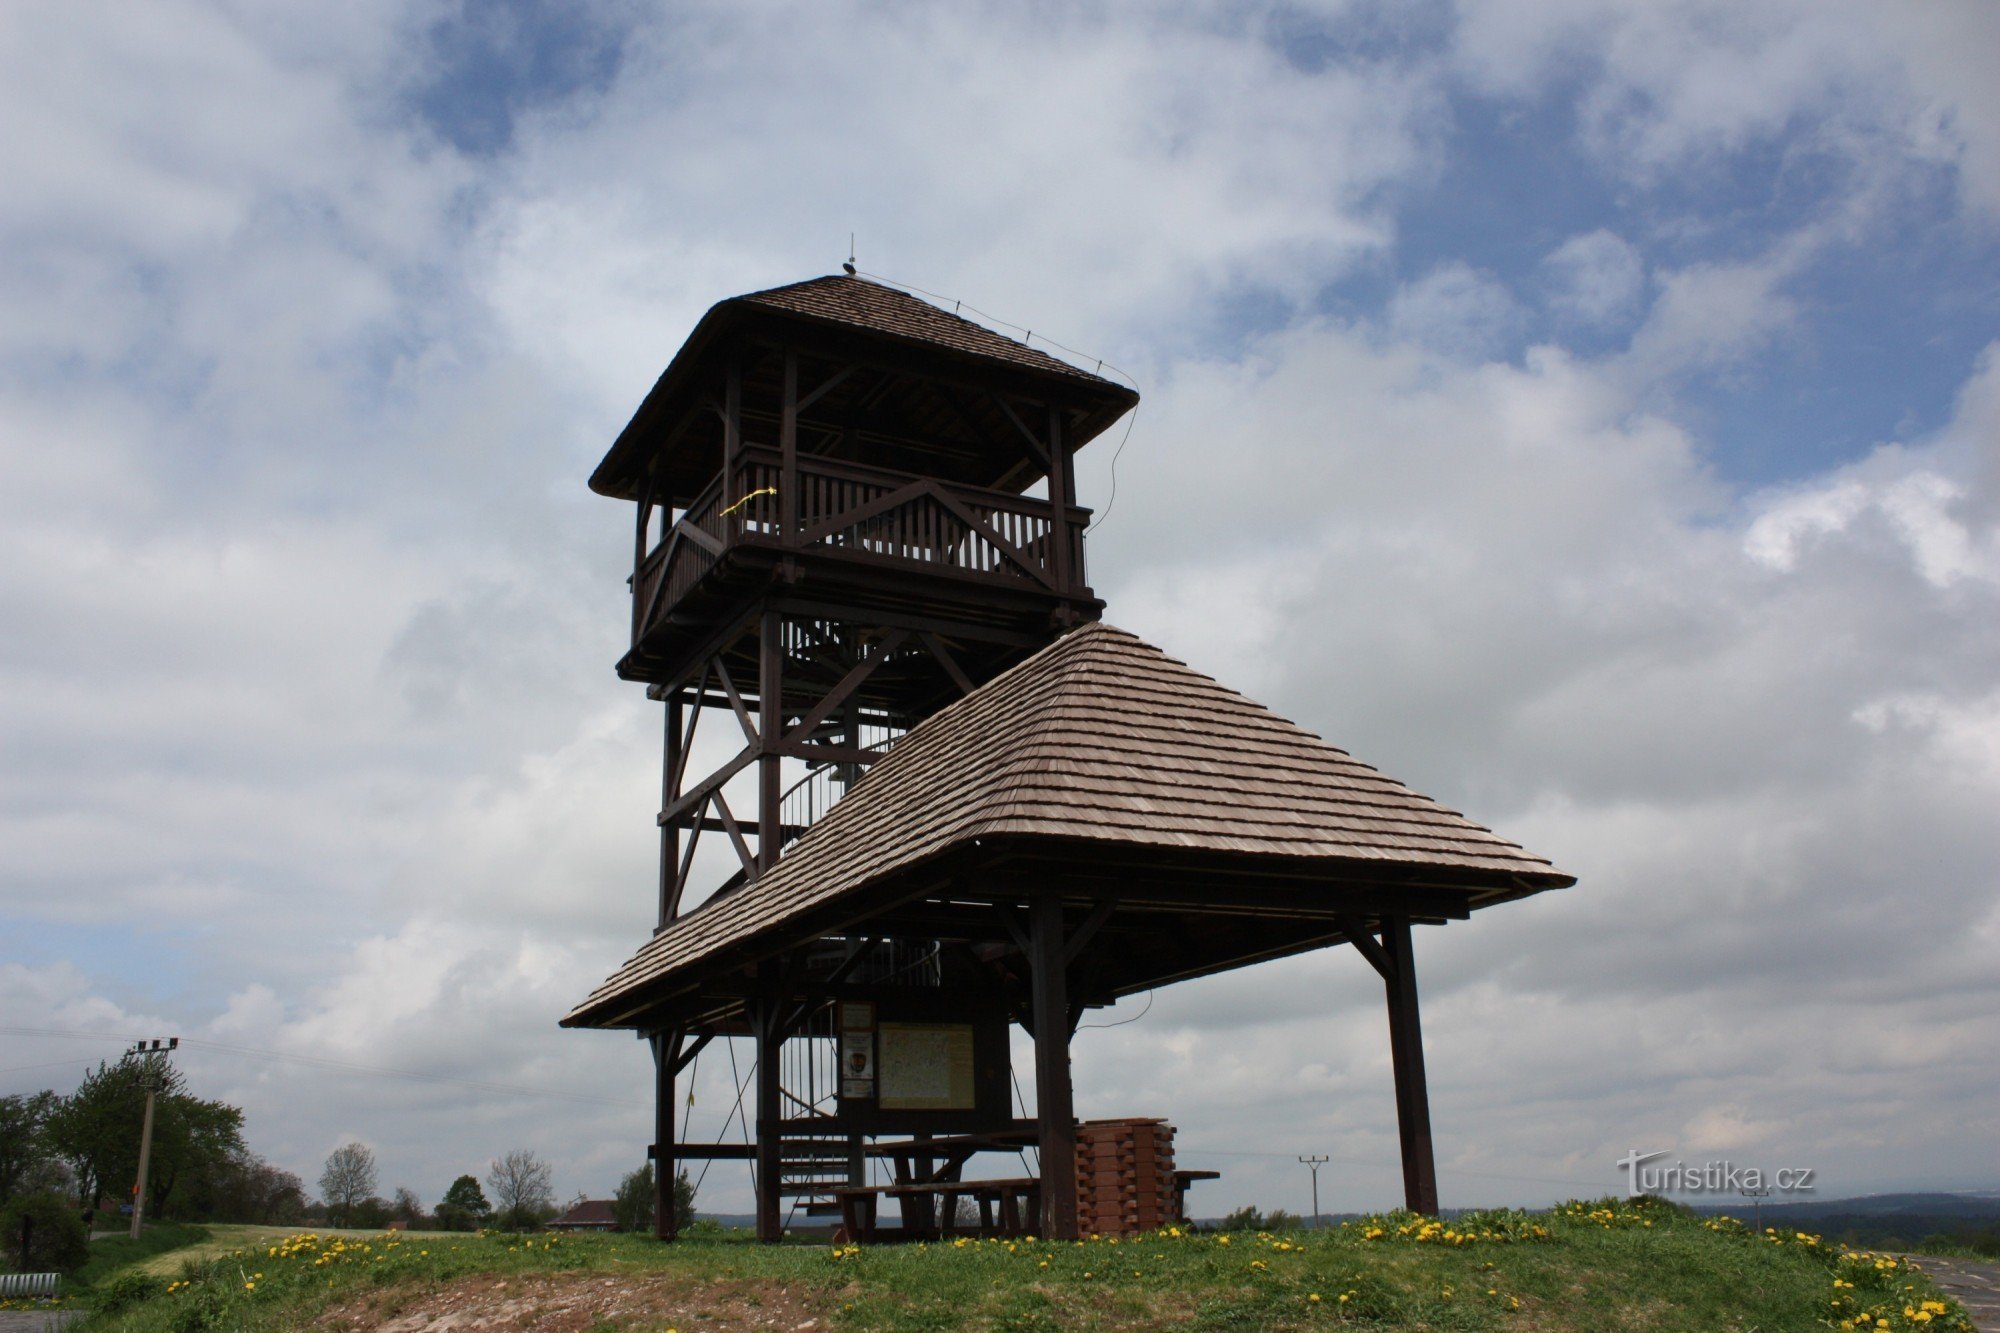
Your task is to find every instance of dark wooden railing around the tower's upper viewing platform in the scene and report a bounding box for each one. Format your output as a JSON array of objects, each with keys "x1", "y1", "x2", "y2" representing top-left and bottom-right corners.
[{"x1": 632, "y1": 448, "x2": 1090, "y2": 642}]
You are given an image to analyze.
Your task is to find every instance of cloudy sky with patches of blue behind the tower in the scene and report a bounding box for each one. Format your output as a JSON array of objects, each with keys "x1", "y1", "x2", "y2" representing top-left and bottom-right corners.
[{"x1": 0, "y1": 0, "x2": 2000, "y2": 1213}]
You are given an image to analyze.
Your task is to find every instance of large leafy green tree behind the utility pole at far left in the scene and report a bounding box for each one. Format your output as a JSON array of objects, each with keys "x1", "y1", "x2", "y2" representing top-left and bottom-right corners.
[{"x1": 44, "y1": 1059, "x2": 244, "y2": 1217}]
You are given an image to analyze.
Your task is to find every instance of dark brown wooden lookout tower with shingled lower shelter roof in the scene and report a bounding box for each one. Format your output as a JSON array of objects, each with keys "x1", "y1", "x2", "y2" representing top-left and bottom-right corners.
[{"x1": 564, "y1": 276, "x2": 1574, "y2": 1239}]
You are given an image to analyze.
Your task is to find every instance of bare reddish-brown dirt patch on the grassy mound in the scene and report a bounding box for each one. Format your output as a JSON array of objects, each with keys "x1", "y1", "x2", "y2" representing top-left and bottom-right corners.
[{"x1": 312, "y1": 1273, "x2": 836, "y2": 1333}]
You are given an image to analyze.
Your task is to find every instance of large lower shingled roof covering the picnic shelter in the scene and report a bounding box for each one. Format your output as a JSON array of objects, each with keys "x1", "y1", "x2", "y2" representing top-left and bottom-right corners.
[{"x1": 564, "y1": 622, "x2": 1574, "y2": 1027}]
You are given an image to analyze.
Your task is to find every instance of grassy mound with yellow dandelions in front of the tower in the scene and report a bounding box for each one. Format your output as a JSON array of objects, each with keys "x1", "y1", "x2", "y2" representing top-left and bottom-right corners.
[{"x1": 58, "y1": 1201, "x2": 1972, "y2": 1333}]
